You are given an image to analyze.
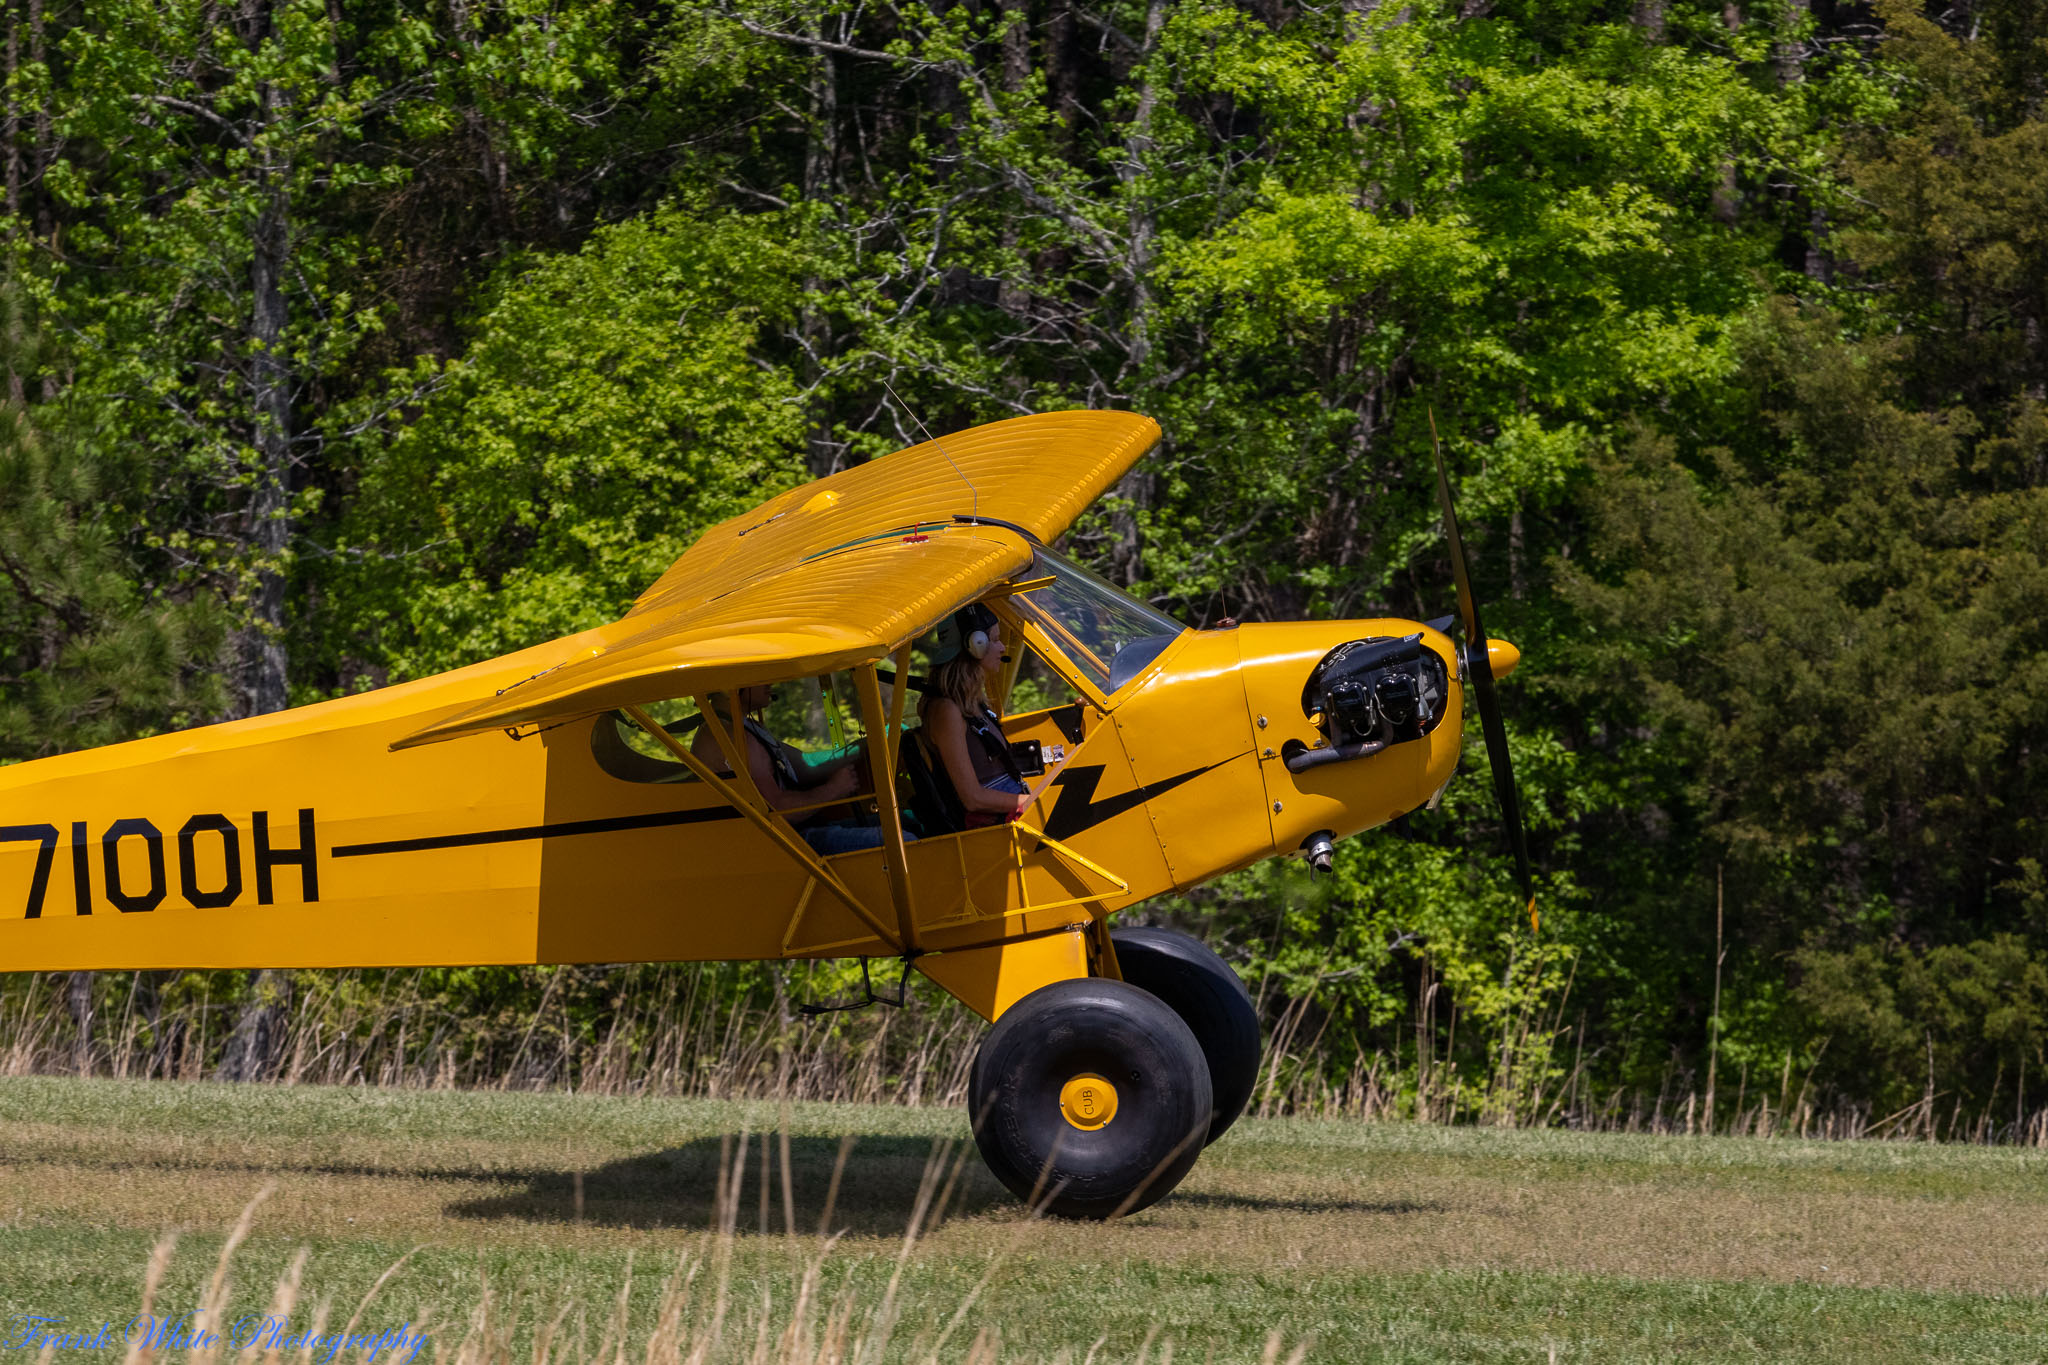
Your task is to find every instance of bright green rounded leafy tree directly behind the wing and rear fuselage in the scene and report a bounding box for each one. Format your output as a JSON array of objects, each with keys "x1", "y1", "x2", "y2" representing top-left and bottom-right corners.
[{"x1": 336, "y1": 207, "x2": 803, "y2": 675}]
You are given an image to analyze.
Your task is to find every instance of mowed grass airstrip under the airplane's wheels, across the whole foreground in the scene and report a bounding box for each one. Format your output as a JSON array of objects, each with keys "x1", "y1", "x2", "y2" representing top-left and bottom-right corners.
[{"x1": 0, "y1": 1078, "x2": 2048, "y2": 1363}]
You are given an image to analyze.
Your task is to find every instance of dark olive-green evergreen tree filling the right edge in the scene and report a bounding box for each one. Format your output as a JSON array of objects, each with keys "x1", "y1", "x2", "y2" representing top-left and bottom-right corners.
[{"x1": 1563, "y1": 6, "x2": 2048, "y2": 1109}]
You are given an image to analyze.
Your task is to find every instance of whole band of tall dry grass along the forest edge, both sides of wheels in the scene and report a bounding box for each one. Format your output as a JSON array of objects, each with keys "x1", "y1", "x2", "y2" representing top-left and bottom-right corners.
[{"x1": 0, "y1": 964, "x2": 2048, "y2": 1148}]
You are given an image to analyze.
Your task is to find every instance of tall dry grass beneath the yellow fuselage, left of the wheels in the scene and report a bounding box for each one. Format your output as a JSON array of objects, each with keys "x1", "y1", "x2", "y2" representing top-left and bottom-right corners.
[{"x1": 0, "y1": 964, "x2": 983, "y2": 1105}]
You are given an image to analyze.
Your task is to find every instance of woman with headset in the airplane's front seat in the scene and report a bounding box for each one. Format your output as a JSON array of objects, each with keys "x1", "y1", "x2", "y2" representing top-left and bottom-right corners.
[{"x1": 918, "y1": 602, "x2": 1030, "y2": 827}]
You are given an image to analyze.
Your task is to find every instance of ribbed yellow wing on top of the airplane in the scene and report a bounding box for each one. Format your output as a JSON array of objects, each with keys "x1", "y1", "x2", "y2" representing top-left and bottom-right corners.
[{"x1": 393, "y1": 411, "x2": 1159, "y2": 749}]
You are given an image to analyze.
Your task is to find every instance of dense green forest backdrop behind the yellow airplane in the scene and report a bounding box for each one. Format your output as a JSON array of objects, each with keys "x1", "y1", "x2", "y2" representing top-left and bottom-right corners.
[{"x1": 0, "y1": 0, "x2": 2048, "y2": 1136}]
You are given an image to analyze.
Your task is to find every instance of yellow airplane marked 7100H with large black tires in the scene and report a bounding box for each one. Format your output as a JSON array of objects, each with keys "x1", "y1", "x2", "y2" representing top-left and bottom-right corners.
[{"x1": 0, "y1": 411, "x2": 1526, "y2": 1218}]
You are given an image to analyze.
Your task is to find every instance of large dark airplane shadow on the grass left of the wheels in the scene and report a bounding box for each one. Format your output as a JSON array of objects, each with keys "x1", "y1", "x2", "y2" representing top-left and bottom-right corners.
[{"x1": 446, "y1": 1134, "x2": 1012, "y2": 1236}]
